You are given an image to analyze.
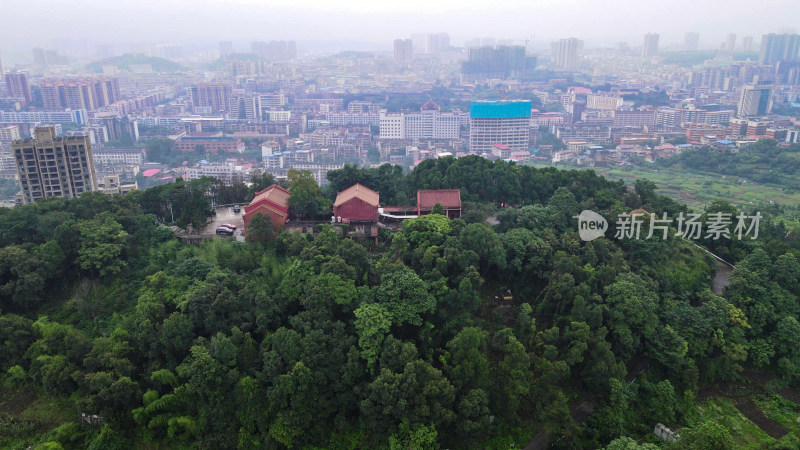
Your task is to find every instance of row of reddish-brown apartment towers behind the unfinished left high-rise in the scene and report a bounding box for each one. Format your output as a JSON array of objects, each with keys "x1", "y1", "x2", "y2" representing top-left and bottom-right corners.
[{"x1": 39, "y1": 77, "x2": 122, "y2": 111}]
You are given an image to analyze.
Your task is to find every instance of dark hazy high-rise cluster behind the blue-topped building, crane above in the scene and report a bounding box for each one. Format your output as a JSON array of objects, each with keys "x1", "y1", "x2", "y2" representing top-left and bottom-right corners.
[{"x1": 461, "y1": 45, "x2": 536, "y2": 79}]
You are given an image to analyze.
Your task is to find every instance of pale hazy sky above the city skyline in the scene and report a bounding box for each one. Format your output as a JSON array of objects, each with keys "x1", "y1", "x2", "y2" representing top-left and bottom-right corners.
[{"x1": 0, "y1": 0, "x2": 800, "y2": 62}]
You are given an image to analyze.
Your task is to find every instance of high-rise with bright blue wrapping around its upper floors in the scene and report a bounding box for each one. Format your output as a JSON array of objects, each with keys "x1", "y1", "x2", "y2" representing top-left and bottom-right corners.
[{"x1": 469, "y1": 100, "x2": 531, "y2": 154}]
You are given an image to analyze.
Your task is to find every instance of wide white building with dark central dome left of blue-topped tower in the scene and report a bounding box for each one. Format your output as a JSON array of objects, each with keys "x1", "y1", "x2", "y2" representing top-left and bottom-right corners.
[{"x1": 379, "y1": 100, "x2": 461, "y2": 140}]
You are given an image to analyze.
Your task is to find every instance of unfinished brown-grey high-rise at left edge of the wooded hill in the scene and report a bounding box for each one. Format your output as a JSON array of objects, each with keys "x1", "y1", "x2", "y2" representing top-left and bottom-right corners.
[{"x1": 11, "y1": 126, "x2": 97, "y2": 204}]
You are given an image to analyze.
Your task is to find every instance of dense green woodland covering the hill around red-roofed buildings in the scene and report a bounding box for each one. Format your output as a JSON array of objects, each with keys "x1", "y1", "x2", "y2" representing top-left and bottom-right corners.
[{"x1": 0, "y1": 157, "x2": 800, "y2": 449}]
